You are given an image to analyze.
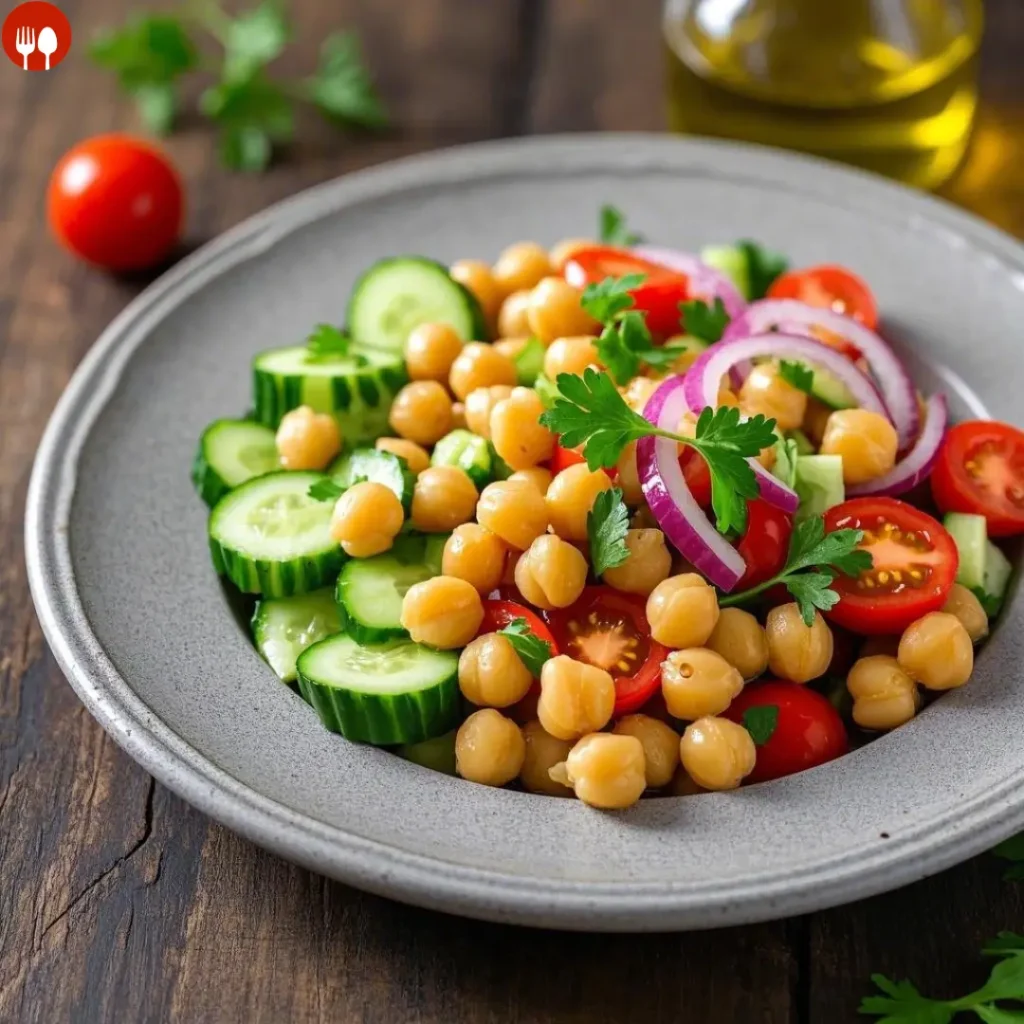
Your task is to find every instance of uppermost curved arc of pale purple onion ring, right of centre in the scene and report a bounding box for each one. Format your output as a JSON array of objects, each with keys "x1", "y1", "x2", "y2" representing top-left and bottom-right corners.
[{"x1": 722, "y1": 299, "x2": 921, "y2": 452}]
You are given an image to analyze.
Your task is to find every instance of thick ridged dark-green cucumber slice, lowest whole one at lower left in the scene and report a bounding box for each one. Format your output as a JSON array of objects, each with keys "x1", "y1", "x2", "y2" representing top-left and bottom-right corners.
[{"x1": 298, "y1": 635, "x2": 461, "y2": 746}]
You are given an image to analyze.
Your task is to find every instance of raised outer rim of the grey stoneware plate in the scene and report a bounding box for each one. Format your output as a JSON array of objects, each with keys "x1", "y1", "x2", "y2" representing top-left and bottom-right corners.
[{"x1": 25, "y1": 133, "x2": 1024, "y2": 931}]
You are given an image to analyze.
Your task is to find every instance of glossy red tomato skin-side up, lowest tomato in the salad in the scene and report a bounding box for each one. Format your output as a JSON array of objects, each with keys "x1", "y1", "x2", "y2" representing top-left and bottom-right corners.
[{"x1": 725, "y1": 680, "x2": 850, "y2": 782}]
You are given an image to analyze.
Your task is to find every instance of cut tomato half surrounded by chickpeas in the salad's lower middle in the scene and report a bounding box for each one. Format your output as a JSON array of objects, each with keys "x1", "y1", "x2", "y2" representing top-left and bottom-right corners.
[{"x1": 544, "y1": 587, "x2": 669, "y2": 717}]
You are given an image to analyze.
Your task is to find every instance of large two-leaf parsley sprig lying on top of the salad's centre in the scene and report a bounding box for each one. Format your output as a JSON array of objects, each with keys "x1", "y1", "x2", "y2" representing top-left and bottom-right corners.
[{"x1": 541, "y1": 368, "x2": 775, "y2": 534}]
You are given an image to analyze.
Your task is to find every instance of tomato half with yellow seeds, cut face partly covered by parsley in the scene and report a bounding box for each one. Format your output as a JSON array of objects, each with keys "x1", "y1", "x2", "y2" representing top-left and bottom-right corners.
[{"x1": 825, "y1": 498, "x2": 959, "y2": 634}]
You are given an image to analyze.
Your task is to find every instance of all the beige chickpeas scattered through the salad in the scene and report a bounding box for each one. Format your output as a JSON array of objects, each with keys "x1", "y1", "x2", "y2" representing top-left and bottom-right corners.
[{"x1": 268, "y1": 242, "x2": 988, "y2": 808}]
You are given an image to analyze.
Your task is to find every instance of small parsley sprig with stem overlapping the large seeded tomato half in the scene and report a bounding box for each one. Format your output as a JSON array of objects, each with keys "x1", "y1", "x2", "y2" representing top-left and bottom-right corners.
[{"x1": 719, "y1": 516, "x2": 871, "y2": 626}]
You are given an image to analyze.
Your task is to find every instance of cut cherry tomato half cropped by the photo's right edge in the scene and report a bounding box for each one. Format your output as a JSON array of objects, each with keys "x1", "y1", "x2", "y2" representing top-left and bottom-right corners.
[{"x1": 932, "y1": 420, "x2": 1024, "y2": 537}]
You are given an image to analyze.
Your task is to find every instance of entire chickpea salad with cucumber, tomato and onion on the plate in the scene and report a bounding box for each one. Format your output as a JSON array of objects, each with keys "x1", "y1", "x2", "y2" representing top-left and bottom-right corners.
[{"x1": 193, "y1": 207, "x2": 1024, "y2": 809}]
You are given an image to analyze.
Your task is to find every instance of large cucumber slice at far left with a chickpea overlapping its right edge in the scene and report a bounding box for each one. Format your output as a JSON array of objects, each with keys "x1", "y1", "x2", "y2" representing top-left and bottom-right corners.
[{"x1": 208, "y1": 471, "x2": 345, "y2": 597}]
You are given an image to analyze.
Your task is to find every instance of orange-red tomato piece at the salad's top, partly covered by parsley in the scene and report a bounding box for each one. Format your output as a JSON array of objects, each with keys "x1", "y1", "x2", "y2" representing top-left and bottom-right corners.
[{"x1": 562, "y1": 246, "x2": 690, "y2": 339}]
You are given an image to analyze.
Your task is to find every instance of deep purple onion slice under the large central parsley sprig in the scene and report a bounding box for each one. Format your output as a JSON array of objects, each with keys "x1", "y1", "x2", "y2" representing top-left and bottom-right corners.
[{"x1": 637, "y1": 377, "x2": 746, "y2": 591}]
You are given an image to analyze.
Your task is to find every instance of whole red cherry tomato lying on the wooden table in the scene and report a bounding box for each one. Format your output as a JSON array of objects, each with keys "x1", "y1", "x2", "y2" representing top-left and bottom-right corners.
[{"x1": 46, "y1": 134, "x2": 184, "y2": 271}]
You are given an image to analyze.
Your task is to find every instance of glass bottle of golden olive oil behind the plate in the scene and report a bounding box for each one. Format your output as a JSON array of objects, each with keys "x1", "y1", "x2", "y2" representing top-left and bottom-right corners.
[{"x1": 664, "y1": 0, "x2": 982, "y2": 188}]
